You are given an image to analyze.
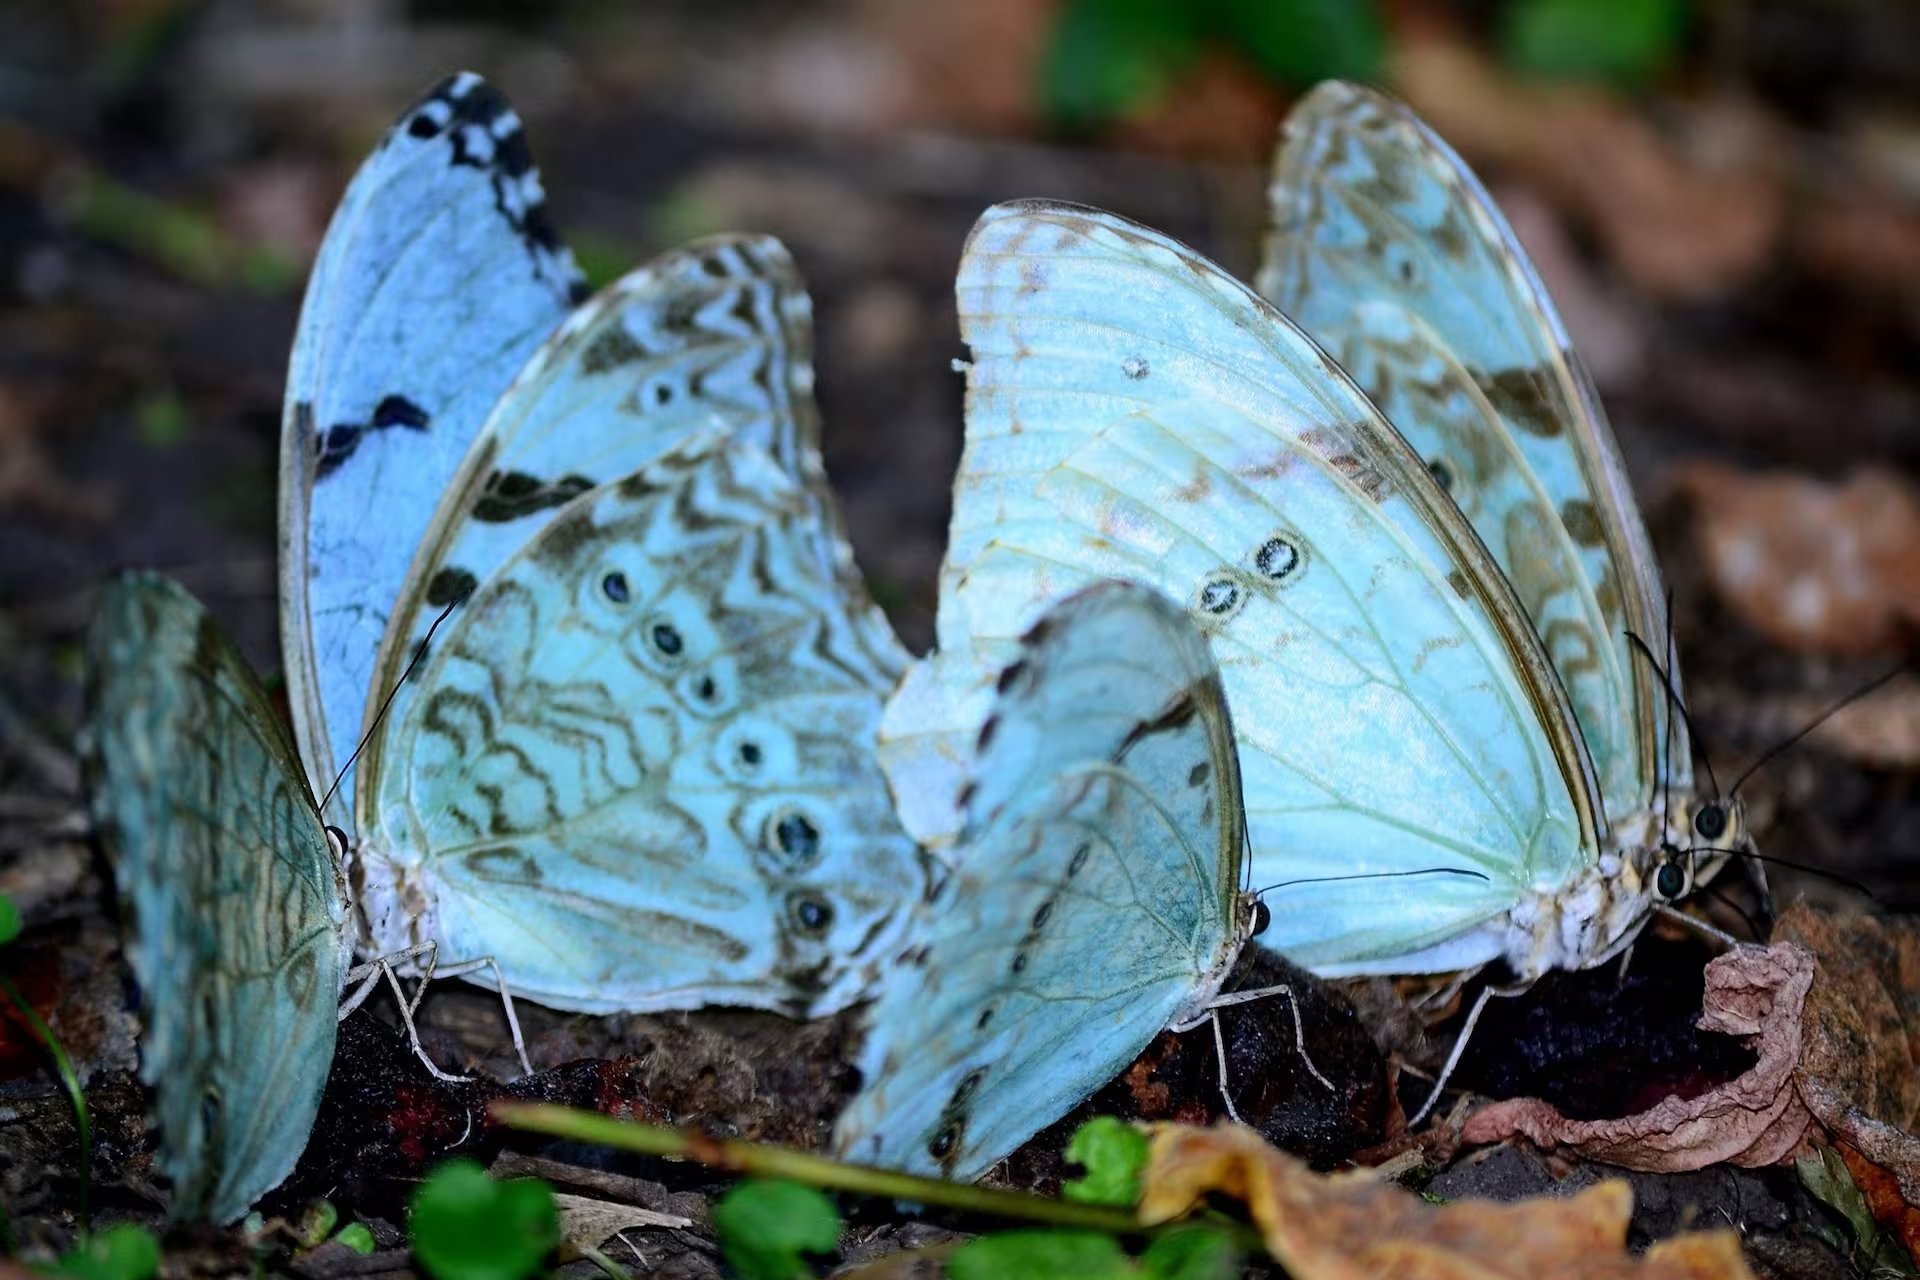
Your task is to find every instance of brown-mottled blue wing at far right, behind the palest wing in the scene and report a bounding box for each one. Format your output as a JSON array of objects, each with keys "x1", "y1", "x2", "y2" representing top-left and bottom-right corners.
[{"x1": 1260, "y1": 83, "x2": 1692, "y2": 816}]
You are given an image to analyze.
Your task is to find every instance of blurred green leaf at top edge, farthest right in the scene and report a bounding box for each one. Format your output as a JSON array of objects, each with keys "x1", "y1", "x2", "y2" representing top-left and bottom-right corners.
[{"x1": 1500, "y1": 0, "x2": 1688, "y2": 86}]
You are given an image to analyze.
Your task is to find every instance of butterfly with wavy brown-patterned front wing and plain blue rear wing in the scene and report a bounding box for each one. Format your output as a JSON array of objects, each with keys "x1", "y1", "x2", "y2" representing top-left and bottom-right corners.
[{"x1": 280, "y1": 75, "x2": 924, "y2": 1015}]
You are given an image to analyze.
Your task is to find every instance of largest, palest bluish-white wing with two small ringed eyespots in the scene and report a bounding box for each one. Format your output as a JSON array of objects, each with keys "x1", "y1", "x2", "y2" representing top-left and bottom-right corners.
[{"x1": 885, "y1": 201, "x2": 1597, "y2": 973}]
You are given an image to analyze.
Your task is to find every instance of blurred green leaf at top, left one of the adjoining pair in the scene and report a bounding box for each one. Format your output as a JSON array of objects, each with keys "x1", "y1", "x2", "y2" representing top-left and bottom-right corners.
[{"x1": 1041, "y1": 0, "x2": 1200, "y2": 129}]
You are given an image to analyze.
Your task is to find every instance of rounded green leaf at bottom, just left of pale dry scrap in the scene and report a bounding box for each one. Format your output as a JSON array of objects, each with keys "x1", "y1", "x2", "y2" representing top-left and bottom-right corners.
[{"x1": 407, "y1": 1159, "x2": 561, "y2": 1280}]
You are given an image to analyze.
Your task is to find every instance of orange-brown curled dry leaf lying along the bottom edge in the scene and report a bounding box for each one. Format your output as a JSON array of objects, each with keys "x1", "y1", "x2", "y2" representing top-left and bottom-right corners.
[{"x1": 1140, "y1": 1125, "x2": 1753, "y2": 1280}]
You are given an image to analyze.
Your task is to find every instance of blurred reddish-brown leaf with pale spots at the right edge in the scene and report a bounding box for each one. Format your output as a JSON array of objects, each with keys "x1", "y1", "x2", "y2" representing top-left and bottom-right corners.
[{"x1": 1676, "y1": 462, "x2": 1920, "y2": 656}]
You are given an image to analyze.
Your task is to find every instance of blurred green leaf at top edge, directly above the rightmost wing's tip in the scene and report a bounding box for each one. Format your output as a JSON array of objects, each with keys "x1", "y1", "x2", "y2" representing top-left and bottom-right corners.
[{"x1": 1200, "y1": 0, "x2": 1386, "y2": 88}]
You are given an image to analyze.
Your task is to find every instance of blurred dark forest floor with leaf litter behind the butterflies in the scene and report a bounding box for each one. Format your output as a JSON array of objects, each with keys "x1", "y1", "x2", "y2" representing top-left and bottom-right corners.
[{"x1": 0, "y1": 0, "x2": 1920, "y2": 906}]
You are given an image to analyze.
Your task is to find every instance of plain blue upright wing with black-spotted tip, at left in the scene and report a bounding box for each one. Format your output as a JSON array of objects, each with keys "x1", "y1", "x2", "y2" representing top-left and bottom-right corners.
[{"x1": 280, "y1": 73, "x2": 580, "y2": 825}]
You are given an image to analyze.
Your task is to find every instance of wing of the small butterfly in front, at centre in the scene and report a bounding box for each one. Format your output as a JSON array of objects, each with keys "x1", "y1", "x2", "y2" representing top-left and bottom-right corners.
[{"x1": 833, "y1": 583, "x2": 1244, "y2": 1180}]
